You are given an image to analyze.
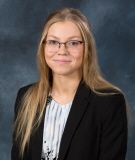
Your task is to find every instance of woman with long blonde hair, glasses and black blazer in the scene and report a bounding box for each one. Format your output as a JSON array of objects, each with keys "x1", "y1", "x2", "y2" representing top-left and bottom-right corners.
[{"x1": 11, "y1": 8, "x2": 127, "y2": 160}]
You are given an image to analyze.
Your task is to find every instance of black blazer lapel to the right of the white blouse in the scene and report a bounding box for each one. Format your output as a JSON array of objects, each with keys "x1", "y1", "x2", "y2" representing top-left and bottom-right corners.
[{"x1": 58, "y1": 81, "x2": 91, "y2": 160}]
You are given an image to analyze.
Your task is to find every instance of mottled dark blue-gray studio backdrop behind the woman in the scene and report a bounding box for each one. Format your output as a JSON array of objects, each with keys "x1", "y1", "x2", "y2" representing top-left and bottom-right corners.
[{"x1": 0, "y1": 0, "x2": 135, "y2": 160}]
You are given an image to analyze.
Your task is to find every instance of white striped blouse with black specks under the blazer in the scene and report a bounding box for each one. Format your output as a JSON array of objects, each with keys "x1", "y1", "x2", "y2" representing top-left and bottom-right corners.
[{"x1": 41, "y1": 96, "x2": 72, "y2": 160}]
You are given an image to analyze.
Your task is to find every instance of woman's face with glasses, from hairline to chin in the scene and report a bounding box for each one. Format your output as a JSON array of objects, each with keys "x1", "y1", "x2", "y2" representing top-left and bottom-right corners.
[{"x1": 44, "y1": 21, "x2": 84, "y2": 76}]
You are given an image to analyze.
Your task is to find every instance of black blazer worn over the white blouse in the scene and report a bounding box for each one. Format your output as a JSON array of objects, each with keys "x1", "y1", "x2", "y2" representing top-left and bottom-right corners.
[{"x1": 11, "y1": 82, "x2": 128, "y2": 160}]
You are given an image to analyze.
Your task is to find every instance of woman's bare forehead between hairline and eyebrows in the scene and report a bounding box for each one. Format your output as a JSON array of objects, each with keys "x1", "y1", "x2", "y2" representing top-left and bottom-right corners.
[{"x1": 47, "y1": 21, "x2": 81, "y2": 38}]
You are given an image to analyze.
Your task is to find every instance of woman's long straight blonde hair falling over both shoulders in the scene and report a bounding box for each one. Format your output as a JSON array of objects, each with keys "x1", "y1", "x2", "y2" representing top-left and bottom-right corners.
[{"x1": 14, "y1": 8, "x2": 123, "y2": 156}]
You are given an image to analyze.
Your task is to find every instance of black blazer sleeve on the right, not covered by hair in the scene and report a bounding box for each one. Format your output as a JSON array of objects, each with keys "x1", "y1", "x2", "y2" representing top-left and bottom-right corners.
[{"x1": 99, "y1": 93, "x2": 128, "y2": 160}]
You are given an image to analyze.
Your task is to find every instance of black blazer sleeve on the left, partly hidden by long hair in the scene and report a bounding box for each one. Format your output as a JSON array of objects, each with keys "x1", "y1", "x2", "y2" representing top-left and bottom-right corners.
[{"x1": 11, "y1": 85, "x2": 30, "y2": 160}]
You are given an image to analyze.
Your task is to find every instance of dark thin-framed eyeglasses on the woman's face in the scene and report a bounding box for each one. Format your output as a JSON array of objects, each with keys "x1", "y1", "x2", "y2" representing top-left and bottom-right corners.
[{"x1": 44, "y1": 40, "x2": 84, "y2": 52}]
